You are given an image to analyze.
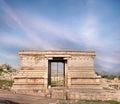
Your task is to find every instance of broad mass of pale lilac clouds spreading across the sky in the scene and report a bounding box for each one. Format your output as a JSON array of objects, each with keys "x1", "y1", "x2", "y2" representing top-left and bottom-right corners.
[{"x1": 0, "y1": 0, "x2": 120, "y2": 72}]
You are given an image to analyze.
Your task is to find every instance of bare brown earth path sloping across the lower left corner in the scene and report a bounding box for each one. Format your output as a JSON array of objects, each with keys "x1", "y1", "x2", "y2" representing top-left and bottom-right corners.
[{"x1": 0, "y1": 90, "x2": 60, "y2": 104}]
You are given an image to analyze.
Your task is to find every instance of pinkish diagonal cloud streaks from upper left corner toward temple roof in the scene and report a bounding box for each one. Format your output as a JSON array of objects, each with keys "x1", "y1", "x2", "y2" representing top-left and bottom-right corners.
[{"x1": 1, "y1": 2, "x2": 79, "y2": 49}]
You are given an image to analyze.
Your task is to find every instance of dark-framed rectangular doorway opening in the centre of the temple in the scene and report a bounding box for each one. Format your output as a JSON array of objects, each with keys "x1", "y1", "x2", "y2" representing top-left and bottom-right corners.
[{"x1": 48, "y1": 58, "x2": 65, "y2": 87}]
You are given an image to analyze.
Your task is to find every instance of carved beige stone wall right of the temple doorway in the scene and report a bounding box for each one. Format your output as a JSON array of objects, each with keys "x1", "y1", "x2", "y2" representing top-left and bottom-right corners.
[{"x1": 68, "y1": 55, "x2": 100, "y2": 89}]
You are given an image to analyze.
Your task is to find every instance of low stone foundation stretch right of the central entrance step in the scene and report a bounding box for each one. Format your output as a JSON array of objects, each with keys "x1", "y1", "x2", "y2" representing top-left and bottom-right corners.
[{"x1": 67, "y1": 90, "x2": 120, "y2": 101}]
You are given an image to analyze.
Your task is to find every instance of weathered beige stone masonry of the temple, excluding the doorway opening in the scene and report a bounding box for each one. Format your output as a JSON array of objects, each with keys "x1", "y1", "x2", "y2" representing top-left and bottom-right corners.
[{"x1": 12, "y1": 50, "x2": 101, "y2": 99}]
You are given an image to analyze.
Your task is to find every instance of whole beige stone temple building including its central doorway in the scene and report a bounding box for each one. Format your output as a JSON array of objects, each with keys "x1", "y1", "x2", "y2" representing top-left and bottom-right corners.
[{"x1": 12, "y1": 50, "x2": 101, "y2": 99}]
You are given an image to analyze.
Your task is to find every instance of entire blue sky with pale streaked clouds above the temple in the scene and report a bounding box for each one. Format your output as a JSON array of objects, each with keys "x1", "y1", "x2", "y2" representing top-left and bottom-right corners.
[{"x1": 0, "y1": 0, "x2": 120, "y2": 72}]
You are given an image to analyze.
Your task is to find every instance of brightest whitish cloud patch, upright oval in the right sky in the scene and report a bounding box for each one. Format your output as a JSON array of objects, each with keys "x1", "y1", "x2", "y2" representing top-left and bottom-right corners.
[{"x1": 80, "y1": 15, "x2": 100, "y2": 47}]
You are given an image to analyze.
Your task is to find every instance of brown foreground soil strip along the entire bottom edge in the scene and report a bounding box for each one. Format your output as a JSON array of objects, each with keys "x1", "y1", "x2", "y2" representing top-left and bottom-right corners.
[{"x1": 0, "y1": 90, "x2": 120, "y2": 104}]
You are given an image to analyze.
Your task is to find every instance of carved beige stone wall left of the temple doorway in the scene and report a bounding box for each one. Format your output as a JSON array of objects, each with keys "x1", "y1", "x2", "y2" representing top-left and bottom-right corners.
[{"x1": 12, "y1": 54, "x2": 48, "y2": 90}]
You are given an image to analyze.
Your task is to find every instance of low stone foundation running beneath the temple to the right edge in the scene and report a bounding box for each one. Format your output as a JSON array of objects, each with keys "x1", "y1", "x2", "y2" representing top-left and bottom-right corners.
[{"x1": 11, "y1": 88, "x2": 120, "y2": 101}]
